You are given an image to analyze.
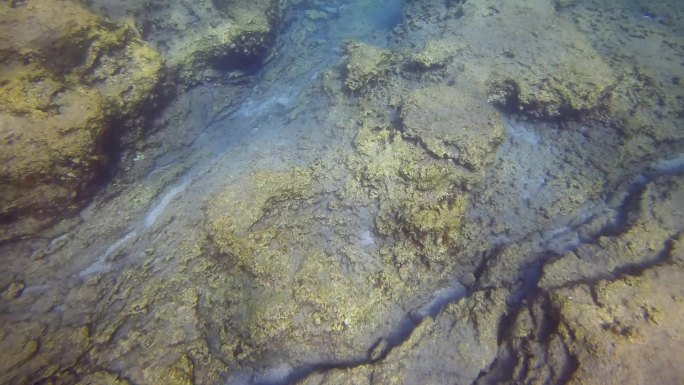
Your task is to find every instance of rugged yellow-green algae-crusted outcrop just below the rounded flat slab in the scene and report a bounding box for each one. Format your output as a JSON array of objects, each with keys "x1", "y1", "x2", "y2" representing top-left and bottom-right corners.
[{"x1": 347, "y1": 114, "x2": 470, "y2": 268}]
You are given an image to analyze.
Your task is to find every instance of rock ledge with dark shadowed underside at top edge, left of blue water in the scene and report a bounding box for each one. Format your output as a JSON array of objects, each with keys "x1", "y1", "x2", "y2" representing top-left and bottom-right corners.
[{"x1": 81, "y1": 0, "x2": 284, "y2": 86}]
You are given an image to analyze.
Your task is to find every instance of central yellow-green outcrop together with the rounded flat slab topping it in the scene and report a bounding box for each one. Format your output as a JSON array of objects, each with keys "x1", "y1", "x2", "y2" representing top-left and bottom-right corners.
[{"x1": 340, "y1": 79, "x2": 503, "y2": 288}]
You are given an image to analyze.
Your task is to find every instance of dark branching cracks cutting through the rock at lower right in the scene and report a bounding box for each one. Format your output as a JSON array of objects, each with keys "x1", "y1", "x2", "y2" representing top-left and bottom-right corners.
[{"x1": 239, "y1": 151, "x2": 684, "y2": 385}]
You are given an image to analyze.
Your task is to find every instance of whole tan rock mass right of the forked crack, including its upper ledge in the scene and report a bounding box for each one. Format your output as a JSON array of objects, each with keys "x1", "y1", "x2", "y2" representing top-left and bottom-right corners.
[{"x1": 482, "y1": 177, "x2": 684, "y2": 384}]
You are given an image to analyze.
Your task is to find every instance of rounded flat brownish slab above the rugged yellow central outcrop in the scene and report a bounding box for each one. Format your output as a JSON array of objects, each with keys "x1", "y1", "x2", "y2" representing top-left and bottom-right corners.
[{"x1": 401, "y1": 85, "x2": 503, "y2": 171}]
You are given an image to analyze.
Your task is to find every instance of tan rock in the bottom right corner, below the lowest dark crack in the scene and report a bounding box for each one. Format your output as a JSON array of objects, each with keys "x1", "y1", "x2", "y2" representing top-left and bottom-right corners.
[{"x1": 492, "y1": 257, "x2": 684, "y2": 384}]
